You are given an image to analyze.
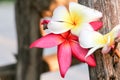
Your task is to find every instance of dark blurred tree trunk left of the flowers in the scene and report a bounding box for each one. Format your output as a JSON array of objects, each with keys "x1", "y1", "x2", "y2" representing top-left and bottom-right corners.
[{"x1": 15, "y1": 0, "x2": 50, "y2": 80}]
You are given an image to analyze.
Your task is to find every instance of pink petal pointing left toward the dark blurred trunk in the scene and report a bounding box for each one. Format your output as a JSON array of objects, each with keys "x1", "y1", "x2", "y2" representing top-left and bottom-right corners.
[{"x1": 30, "y1": 33, "x2": 64, "y2": 48}]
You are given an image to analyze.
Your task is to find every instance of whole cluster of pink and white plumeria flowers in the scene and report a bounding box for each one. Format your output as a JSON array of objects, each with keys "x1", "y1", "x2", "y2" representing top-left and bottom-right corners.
[{"x1": 30, "y1": 2, "x2": 120, "y2": 77}]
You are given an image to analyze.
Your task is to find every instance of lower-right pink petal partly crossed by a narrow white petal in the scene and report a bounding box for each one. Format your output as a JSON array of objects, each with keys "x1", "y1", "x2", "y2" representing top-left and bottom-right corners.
[{"x1": 70, "y1": 41, "x2": 96, "y2": 66}]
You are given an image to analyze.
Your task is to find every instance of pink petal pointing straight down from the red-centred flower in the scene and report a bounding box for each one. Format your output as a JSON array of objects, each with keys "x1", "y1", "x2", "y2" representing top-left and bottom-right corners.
[{"x1": 58, "y1": 41, "x2": 72, "y2": 77}]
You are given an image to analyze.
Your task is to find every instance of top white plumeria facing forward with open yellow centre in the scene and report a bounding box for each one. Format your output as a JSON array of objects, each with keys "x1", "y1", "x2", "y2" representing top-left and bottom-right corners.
[{"x1": 48, "y1": 2, "x2": 102, "y2": 36}]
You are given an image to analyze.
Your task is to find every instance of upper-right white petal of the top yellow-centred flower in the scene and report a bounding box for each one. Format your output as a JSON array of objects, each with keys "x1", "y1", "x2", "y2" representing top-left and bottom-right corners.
[{"x1": 69, "y1": 2, "x2": 102, "y2": 22}]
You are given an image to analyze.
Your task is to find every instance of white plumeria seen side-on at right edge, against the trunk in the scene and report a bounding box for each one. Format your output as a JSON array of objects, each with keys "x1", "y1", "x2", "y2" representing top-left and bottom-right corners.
[{"x1": 79, "y1": 24, "x2": 120, "y2": 57}]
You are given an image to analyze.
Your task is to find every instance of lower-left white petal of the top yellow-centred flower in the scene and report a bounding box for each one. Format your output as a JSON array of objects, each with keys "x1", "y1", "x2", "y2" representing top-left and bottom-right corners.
[{"x1": 48, "y1": 21, "x2": 73, "y2": 34}]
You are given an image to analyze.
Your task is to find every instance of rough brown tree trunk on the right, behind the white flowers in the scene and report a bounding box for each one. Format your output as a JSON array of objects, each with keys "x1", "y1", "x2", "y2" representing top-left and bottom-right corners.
[{"x1": 79, "y1": 0, "x2": 120, "y2": 80}]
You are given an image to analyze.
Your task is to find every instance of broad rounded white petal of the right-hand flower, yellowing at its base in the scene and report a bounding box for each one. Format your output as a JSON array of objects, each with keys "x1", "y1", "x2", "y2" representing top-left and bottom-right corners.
[{"x1": 79, "y1": 30, "x2": 105, "y2": 48}]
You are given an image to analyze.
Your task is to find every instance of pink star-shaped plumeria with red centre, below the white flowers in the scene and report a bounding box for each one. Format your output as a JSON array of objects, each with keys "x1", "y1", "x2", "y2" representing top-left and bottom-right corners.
[{"x1": 30, "y1": 31, "x2": 96, "y2": 77}]
